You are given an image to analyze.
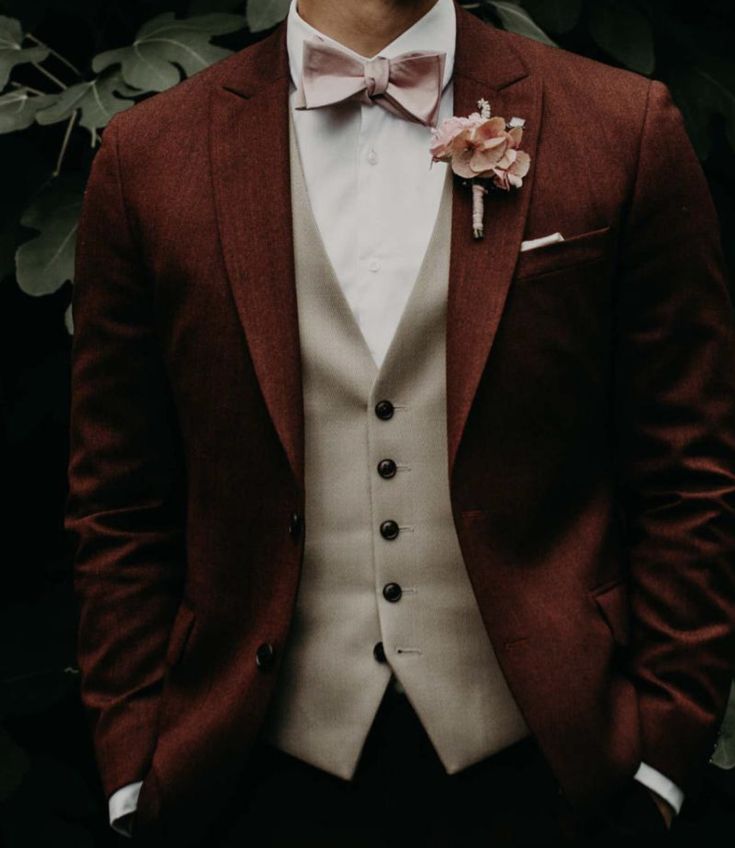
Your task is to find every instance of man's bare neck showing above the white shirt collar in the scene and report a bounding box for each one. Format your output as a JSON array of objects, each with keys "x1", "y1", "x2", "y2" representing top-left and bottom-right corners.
[{"x1": 296, "y1": 0, "x2": 437, "y2": 57}]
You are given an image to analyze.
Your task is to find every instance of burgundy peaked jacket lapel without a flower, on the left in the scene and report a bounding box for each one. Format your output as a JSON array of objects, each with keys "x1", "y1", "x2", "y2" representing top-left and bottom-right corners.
[{"x1": 209, "y1": 22, "x2": 304, "y2": 491}]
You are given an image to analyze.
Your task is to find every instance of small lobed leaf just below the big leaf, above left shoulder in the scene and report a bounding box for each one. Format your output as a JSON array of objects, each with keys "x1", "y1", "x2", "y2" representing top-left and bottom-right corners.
[{"x1": 36, "y1": 69, "x2": 140, "y2": 141}]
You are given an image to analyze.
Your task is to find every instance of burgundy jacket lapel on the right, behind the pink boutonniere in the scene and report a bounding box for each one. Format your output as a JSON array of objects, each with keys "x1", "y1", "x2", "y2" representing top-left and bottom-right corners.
[{"x1": 447, "y1": 2, "x2": 542, "y2": 479}]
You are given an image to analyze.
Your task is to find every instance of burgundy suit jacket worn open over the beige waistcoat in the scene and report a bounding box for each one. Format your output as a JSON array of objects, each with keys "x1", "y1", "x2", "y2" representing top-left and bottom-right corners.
[{"x1": 61, "y1": 7, "x2": 735, "y2": 844}]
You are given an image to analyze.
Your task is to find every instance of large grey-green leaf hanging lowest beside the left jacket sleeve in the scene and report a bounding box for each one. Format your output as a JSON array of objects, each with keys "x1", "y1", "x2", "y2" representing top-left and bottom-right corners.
[{"x1": 15, "y1": 175, "x2": 84, "y2": 297}]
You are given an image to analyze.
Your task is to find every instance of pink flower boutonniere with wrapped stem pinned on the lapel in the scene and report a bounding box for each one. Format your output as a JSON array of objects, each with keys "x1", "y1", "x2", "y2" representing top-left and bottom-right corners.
[{"x1": 429, "y1": 99, "x2": 531, "y2": 238}]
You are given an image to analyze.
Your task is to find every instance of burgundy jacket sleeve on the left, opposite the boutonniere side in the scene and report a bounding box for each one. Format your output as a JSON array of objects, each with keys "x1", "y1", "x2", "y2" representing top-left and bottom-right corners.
[{"x1": 64, "y1": 116, "x2": 185, "y2": 796}]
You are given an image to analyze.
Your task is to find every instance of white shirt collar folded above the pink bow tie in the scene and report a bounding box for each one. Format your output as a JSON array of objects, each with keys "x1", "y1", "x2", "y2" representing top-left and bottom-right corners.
[{"x1": 286, "y1": 0, "x2": 457, "y2": 93}]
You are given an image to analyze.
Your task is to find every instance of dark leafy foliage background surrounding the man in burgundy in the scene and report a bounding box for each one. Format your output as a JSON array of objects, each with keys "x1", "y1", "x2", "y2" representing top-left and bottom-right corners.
[{"x1": 0, "y1": 0, "x2": 735, "y2": 848}]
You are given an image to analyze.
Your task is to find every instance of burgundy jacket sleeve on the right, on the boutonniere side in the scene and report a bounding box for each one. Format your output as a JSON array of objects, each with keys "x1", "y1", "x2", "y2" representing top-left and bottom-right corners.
[{"x1": 613, "y1": 76, "x2": 735, "y2": 792}]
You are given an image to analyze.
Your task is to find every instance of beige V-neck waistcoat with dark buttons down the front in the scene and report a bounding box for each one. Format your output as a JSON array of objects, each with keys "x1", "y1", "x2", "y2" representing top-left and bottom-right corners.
[{"x1": 263, "y1": 114, "x2": 529, "y2": 779}]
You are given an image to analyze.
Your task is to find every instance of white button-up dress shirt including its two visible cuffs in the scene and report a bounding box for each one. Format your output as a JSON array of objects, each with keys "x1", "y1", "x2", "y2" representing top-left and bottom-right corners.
[{"x1": 109, "y1": 0, "x2": 684, "y2": 836}]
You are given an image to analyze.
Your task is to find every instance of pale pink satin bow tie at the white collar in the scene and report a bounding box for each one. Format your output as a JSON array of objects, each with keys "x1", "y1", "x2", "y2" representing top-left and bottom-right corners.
[{"x1": 296, "y1": 39, "x2": 446, "y2": 127}]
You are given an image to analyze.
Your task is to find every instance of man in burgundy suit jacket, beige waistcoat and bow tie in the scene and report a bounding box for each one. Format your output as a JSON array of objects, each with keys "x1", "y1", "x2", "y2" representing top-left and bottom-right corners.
[{"x1": 67, "y1": 0, "x2": 735, "y2": 845}]
